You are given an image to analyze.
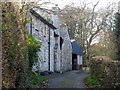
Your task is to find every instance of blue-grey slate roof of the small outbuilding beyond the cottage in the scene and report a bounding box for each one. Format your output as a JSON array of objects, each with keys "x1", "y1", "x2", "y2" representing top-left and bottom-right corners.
[{"x1": 71, "y1": 40, "x2": 83, "y2": 56}]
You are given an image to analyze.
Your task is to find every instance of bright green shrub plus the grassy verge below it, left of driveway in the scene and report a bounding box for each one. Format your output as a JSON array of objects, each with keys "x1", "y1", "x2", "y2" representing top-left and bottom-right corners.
[{"x1": 26, "y1": 34, "x2": 46, "y2": 88}]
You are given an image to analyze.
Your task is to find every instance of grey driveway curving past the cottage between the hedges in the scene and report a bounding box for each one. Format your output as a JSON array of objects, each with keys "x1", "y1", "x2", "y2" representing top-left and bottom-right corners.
[{"x1": 46, "y1": 71, "x2": 89, "y2": 88}]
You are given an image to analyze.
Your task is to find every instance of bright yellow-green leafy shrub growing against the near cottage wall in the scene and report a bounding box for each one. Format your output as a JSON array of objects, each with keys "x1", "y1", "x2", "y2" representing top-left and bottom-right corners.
[{"x1": 27, "y1": 35, "x2": 40, "y2": 69}]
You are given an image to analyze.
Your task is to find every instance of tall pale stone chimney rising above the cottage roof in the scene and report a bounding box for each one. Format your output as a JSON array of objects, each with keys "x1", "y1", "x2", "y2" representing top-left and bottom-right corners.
[{"x1": 52, "y1": 4, "x2": 60, "y2": 35}]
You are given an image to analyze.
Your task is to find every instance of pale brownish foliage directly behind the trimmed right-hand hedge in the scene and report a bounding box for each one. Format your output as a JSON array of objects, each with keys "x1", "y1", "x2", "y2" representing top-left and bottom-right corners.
[{"x1": 90, "y1": 34, "x2": 117, "y2": 59}]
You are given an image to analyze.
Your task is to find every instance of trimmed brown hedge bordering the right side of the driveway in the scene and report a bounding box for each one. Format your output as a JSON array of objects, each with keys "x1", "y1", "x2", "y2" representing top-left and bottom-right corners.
[{"x1": 90, "y1": 57, "x2": 120, "y2": 88}]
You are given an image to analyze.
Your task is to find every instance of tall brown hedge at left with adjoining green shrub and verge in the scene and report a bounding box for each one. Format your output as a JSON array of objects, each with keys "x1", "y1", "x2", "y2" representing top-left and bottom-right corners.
[{"x1": 2, "y1": 2, "x2": 45, "y2": 88}]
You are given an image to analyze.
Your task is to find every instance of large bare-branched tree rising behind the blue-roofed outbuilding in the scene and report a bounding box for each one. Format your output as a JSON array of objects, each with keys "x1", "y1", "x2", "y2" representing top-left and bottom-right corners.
[{"x1": 61, "y1": 1, "x2": 116, "y2": 64}]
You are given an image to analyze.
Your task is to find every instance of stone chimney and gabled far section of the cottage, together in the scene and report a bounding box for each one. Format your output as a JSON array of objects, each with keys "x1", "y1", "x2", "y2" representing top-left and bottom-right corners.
[{"x1": 52, "y1": 5, "x2": 72, "y2": 72}]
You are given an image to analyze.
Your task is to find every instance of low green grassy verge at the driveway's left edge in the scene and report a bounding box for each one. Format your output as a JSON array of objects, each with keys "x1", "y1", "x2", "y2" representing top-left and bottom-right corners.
[{"x1": 28, "y1": 72, "x2": 47, "y2": 88}]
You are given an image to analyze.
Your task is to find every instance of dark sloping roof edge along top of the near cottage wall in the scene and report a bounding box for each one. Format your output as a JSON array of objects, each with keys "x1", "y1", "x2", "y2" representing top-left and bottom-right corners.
[{"x1": 30, "y1": 9, "x2": 57, "y2": 29}]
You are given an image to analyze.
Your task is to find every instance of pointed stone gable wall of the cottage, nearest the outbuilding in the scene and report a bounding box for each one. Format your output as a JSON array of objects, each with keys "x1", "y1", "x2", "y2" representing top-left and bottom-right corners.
[{"x1": 60, "y1": 30, "x2": 72, "y2": 71}]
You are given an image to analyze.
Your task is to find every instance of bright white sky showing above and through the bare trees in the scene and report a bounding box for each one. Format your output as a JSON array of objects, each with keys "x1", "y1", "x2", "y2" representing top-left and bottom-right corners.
[{"x1": 41, "y1": 0, "x2": 120, "y2": 44}]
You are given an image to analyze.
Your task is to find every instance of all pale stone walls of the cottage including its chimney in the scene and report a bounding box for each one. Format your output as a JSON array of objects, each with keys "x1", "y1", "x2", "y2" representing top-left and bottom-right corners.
[{"x1": 27, "y1": 7, "x2": 72, "y2": 72}]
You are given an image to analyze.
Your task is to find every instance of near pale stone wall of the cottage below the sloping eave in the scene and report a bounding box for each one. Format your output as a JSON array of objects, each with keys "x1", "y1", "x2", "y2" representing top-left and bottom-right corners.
[{"x1": 27, "y1": 13, "x2": 54, "y2": 72}]
